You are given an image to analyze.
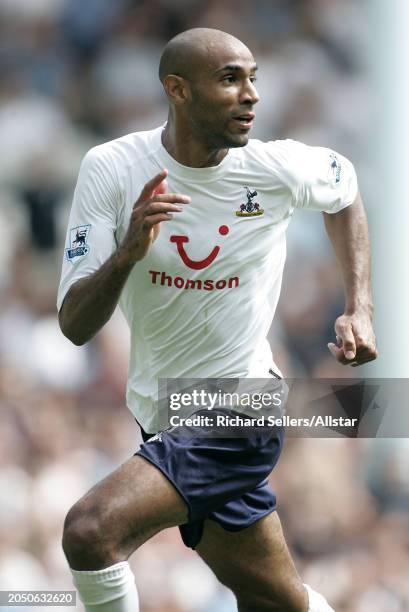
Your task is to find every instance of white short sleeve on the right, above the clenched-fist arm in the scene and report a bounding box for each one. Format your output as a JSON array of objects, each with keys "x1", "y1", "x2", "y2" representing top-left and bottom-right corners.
[{"x1": 274, "y1": 140, "x2": 358, "y2": 213}]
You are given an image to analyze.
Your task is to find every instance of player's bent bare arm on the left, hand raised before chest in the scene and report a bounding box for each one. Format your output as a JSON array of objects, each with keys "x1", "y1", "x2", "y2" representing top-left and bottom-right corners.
[{"x1": 58, "y1": 170, "x2": 190, "y2": 346}]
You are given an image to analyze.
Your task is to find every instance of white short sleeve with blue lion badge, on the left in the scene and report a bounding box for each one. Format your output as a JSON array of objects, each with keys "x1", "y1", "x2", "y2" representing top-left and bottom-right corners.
[{"x1": 57, "y1": 145, "x2": 119, "y2": 310}]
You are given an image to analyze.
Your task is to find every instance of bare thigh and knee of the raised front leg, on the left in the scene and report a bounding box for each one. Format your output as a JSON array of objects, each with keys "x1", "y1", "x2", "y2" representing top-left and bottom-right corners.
[{"x1": 64, "y1": 455, "x2": 188, "y2": 569}]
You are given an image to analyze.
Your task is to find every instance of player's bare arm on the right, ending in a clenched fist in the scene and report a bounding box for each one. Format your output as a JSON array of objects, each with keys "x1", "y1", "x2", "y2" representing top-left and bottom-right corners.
[{"x1": 323, "y1": 192, "x2": 378, "y2": 366}]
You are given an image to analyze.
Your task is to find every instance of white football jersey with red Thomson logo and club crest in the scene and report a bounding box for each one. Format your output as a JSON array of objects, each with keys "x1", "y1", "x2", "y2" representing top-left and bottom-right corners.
[{"x1": 57, "y1": 127, "x2": 357, "y2": 433}]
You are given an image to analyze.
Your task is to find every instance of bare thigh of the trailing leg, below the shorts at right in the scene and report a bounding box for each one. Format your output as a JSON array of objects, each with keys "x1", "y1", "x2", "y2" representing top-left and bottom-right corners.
[{"x1": 196, "y1": 512, "x2": 308, "y2": 612}]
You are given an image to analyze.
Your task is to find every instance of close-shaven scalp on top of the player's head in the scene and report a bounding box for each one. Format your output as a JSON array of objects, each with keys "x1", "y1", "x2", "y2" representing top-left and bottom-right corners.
[{"x1": 159, "y1": 28, "x2": 251, "y2": 83}]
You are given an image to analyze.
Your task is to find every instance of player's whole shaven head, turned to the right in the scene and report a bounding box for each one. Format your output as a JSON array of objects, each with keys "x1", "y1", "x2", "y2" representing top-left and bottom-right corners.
[{"x1": 159, "y1": 28, "x2": 258, "y2": 153}]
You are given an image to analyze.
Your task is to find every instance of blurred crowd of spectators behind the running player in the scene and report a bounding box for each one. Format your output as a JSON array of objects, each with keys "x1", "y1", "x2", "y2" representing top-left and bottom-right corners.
[{"x1": 0, "y1": 0, "x2": 409, "y2": 612}]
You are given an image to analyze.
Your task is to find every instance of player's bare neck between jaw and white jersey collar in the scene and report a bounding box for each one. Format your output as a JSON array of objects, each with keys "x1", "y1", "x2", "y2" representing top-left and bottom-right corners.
[{"x1": 162, "y1": 114, "x2": 228, "y2": 168}]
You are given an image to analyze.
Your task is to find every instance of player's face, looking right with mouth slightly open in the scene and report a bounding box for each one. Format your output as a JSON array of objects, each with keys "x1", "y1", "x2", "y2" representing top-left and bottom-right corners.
[{"x1": 186, "y1": 45, "x2": 259, "y2": 148}]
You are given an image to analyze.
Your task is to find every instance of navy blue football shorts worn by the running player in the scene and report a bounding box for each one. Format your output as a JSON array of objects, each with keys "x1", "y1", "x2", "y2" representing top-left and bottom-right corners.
[{"x1": 135, "y1": 410, "x2": 283, "y2": 548}]
